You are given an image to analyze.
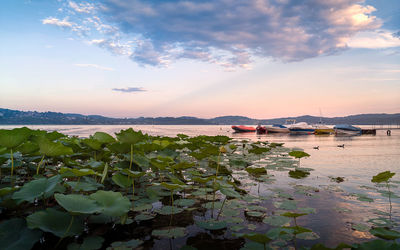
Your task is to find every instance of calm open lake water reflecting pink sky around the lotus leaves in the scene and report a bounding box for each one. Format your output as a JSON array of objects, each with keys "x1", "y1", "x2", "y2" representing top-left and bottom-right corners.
[{"x1": 0, "y1": 125, "x2": 400, "y2": 249}]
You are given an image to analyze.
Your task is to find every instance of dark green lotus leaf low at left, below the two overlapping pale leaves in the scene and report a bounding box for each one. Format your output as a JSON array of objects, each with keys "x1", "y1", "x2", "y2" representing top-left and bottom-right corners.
[{"x1": 26, "y1": 208, "x2": 83, "y2": 237}]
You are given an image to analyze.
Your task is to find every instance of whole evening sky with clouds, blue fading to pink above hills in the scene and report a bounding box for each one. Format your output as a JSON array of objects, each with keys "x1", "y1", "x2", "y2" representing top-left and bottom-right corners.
[{"x1": 0, "y1": 0, "x2": 400, "y2": 119}]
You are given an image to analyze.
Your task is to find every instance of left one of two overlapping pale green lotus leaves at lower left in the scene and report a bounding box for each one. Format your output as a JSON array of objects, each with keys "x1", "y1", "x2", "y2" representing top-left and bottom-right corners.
[{"x1": 54, "y1": 194, "x2": 101, "y2": 214}]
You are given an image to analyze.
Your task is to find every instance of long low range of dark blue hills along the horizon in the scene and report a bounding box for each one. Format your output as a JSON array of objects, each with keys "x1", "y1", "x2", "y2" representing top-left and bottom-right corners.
[{"x1": 0, "y1": 108, "x2": 400, "y2": 125}]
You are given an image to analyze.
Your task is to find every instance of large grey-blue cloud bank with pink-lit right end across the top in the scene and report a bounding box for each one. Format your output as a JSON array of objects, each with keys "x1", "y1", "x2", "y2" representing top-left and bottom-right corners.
[{"x1": 44, "y1": 0, "x2": 390, "y2": 68}]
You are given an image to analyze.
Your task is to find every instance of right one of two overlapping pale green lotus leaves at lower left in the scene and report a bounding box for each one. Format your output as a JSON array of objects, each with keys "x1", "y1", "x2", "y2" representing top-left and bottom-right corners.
[{"x1": 90, "y1": 190, "x2": 131, "y2": 217}]
